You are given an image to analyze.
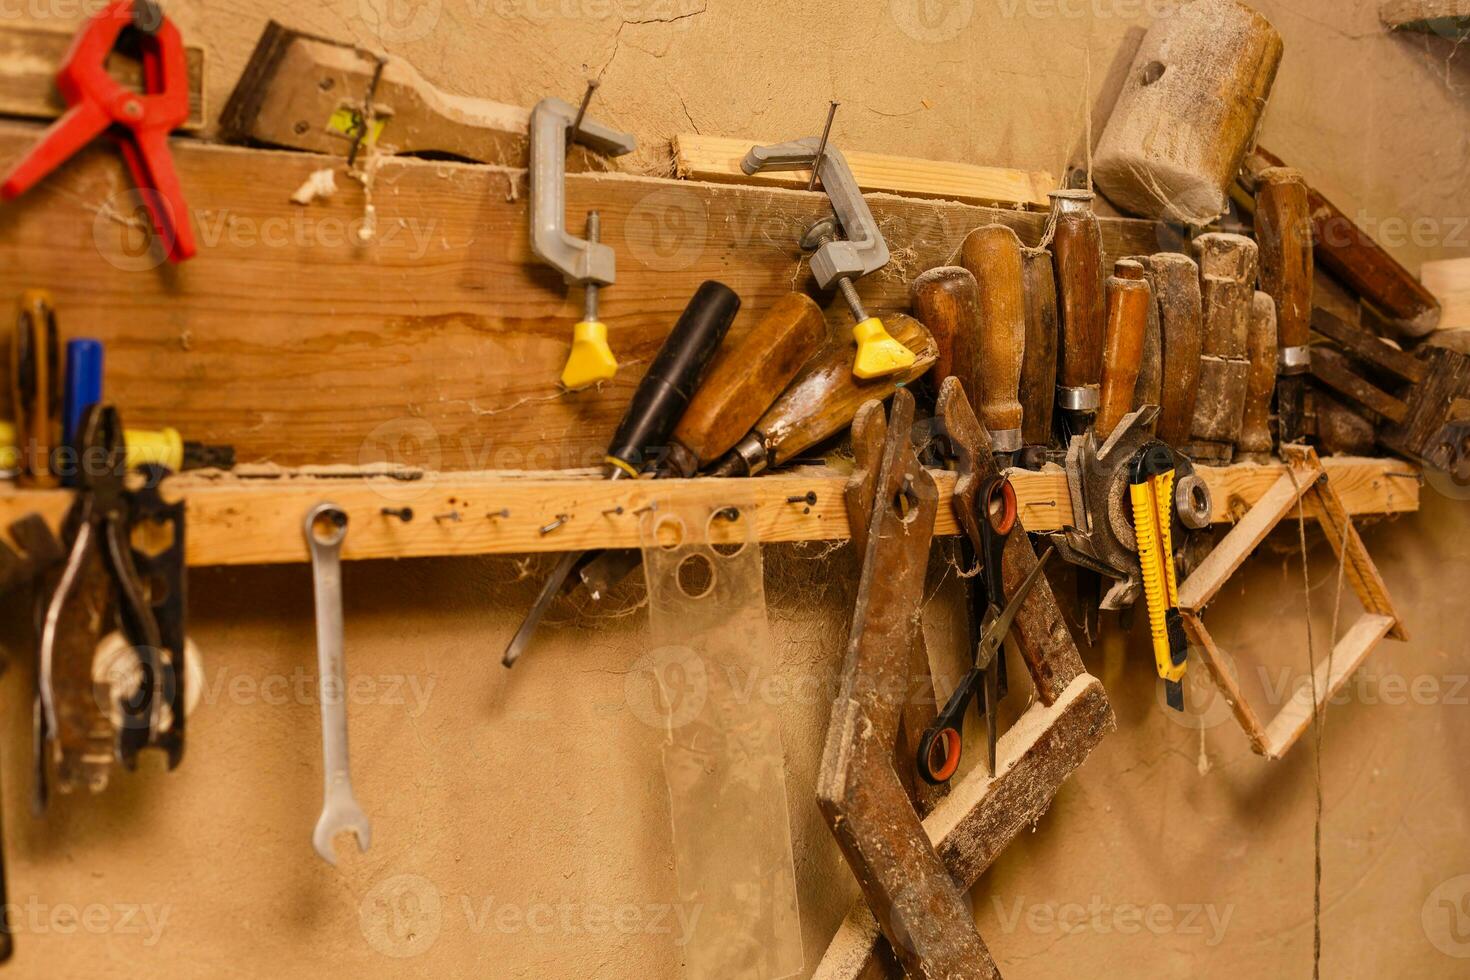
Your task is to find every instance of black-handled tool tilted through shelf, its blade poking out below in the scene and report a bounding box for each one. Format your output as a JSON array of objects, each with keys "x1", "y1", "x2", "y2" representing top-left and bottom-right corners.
[{"x1": 501, "y1": 281, "x2": 739, "y2": 667}]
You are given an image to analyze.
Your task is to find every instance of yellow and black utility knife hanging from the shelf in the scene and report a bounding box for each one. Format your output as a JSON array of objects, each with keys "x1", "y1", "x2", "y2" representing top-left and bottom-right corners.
[{"x1": 1127, "y1": 442, "x2": 1189, "y2": 711}]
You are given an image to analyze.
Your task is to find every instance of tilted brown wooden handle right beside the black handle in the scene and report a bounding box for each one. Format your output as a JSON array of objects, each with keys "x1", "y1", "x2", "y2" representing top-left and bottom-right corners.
[{"x1": 669, "y1": 292, "x2": 828, "y2": 478}]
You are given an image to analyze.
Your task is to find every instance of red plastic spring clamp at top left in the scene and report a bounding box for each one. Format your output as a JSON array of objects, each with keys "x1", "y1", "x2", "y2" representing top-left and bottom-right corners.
[{"x1": 0, "y1": 0, "x2": 197, "y2": 262}]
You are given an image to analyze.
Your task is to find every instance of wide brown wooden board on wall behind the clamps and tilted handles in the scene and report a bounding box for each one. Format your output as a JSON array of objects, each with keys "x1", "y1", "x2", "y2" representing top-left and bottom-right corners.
[{"x1": 0, "y1": 123, "x2": 1160, "y2": 470}]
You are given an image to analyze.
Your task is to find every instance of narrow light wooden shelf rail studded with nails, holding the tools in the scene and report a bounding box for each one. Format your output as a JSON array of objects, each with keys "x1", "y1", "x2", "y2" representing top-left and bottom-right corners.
[{"x1": 0, "y1": 458, "x2": 1420, "y2": 566}]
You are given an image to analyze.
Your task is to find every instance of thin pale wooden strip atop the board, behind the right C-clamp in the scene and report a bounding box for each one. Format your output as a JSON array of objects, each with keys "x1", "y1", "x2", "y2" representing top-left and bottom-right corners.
[{"x1": 673, "y1": 134, "x2": 1057, "y2": 210}]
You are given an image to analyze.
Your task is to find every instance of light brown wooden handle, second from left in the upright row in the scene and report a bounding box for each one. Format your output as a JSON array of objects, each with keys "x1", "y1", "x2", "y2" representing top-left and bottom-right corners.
[{"x1": 956, "y1": 225, "x2": 1026, "y2": 454}]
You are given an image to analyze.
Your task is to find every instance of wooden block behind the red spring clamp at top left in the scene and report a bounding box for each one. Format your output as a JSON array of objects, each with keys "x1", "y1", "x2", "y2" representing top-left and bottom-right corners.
[{"x1": 0, "y1": 25, "x2": 206, "y2": 129}]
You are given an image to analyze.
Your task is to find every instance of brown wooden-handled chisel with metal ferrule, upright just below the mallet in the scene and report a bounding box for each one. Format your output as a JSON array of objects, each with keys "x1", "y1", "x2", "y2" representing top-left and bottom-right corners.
[{"x1": 1255, "y1": 167, "x2": 1316, "y2": 442}]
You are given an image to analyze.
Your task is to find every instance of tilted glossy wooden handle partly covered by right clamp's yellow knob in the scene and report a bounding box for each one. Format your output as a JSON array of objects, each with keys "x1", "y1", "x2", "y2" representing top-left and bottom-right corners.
[{"x1": 710, "y1": 314, "x2": 939, "y2": 476}]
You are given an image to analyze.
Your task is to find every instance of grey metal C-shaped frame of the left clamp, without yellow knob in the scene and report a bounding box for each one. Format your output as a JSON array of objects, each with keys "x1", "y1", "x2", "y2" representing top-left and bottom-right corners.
[{"x1": 531, "y1": 98, "x2": 638, "y2": 287}]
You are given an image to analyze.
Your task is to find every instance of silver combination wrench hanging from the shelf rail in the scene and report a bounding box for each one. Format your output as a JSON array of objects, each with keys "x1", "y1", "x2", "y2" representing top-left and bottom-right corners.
[{"x1": 306, "y1": 504, "x2": 372, "y2": 865}]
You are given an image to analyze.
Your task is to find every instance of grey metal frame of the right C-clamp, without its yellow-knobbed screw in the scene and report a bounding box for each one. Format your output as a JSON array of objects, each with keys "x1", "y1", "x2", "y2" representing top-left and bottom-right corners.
[{"x1": 741, "y1": 137, "x2": 888, "y2": 289}]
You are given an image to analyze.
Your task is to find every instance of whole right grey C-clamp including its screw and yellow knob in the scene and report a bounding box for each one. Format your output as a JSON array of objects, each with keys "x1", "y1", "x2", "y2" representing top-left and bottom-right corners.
[{"x1": 741, "y1": 138, "x2": 914, "y2": 381}]
